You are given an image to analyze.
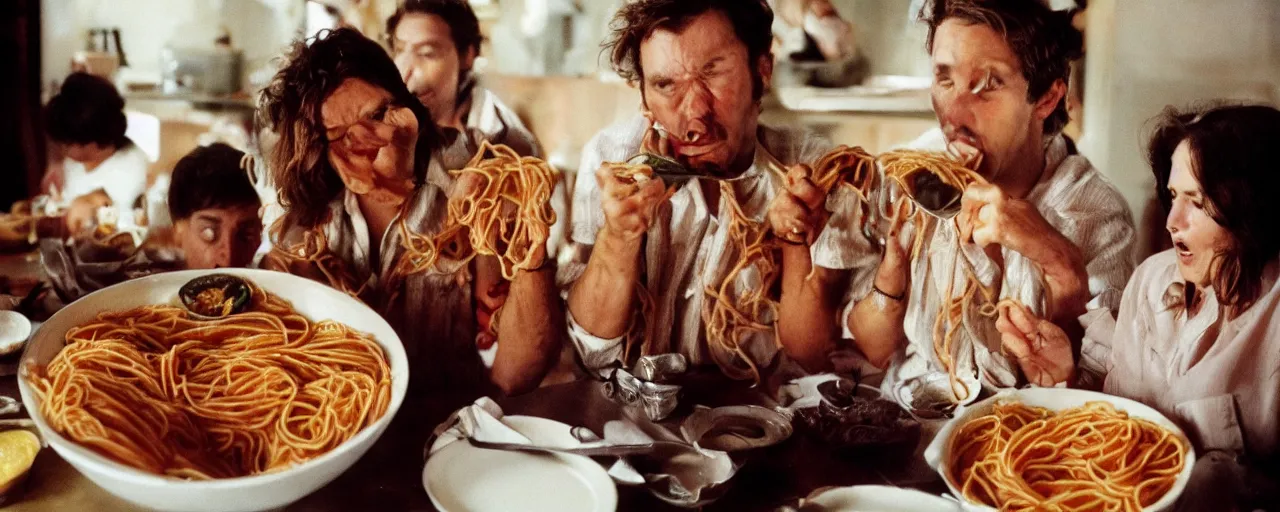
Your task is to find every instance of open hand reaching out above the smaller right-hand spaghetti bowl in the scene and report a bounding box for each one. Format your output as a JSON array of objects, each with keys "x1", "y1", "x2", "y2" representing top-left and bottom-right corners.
[{"x1": 996, "y1": 303, "x2": 1075, "y2": 388}]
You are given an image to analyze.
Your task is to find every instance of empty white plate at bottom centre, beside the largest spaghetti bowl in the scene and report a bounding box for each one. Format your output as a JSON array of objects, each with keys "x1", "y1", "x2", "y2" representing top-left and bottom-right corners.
[{"x1": 422, "y1": 416, "x2": 618, "y2": 512}]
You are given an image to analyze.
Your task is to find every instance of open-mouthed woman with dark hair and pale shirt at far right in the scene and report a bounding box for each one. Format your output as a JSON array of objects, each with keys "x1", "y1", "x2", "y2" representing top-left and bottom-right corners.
[{"x1": 997, "y1": 106, "x2": 1280, "y2": 509}]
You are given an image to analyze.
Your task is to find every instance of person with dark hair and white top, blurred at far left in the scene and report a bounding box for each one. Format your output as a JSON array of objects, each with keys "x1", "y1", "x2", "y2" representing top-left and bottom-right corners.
[{"x1": 44, "y1": 73, "x2": 150, "y2": 233}]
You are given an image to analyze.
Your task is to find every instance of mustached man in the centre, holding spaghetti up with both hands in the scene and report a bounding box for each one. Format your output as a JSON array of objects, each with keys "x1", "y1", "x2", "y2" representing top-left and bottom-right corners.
[{"x1": 567, "y1": 0, "x2": 874, "y2": 379}]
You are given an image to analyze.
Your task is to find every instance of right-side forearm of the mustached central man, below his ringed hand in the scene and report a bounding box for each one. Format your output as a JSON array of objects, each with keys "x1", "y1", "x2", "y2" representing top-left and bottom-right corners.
[{"x1": 778, "y1": 244, "x2": 849, "y2": 372}]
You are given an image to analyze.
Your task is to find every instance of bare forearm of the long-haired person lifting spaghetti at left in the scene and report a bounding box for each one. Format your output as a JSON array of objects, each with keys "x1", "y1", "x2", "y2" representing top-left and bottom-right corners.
[{"x1": 490, "y1": 264, "x2": 566, "y2": 396}]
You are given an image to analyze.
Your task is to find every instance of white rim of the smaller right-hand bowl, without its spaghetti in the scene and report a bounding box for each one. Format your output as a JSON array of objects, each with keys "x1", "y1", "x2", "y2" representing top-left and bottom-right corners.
[{"x1": 924, "y1": 388, "x2": 1196, "y2": 512}]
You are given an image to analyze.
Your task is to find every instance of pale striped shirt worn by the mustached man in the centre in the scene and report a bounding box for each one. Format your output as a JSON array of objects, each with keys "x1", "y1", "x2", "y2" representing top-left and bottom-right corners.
[{"x1": 563, "y1": 116, "x2": 879, "y2": 378}]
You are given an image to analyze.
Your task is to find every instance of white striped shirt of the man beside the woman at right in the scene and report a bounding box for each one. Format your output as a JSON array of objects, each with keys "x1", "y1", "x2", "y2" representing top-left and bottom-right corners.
[{"x1": 860, "y1": 129, "x2": 1135, "y2": 397}]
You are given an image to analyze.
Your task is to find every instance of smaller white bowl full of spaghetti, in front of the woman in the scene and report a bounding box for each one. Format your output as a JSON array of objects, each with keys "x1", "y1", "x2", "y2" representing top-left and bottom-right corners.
[{"x1": 924, "y1": 388, "x2": 1196, "y2": 511}]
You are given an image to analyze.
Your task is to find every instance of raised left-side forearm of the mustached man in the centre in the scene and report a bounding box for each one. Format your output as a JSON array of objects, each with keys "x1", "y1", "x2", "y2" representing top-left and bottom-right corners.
[{"x1": 568, "y1": 229, "x2": 643, "y2": 338}]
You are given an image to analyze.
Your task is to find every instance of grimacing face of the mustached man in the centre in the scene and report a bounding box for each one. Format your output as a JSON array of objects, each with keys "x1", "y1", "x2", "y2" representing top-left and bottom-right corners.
[{"x1": 640, "y1": 10, "x2": 773, "y2": 175}]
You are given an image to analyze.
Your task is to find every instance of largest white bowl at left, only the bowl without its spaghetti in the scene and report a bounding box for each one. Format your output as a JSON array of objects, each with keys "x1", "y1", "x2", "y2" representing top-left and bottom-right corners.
[{"x1": 18, "y1": 269, "x2": 408, "y2": 512}]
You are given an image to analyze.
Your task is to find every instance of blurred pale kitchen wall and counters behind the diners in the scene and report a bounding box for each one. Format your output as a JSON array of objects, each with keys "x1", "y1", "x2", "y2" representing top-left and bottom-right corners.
[{"x1": 0, "y1": 0, "x2": 1280, "y2": 256}]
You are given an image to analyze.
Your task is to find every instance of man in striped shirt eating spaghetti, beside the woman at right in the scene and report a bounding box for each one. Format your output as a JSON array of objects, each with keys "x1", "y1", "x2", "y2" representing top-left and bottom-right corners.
[{"x1": 841, "y1": 0, "x2": 1134, "y2": 399}]
